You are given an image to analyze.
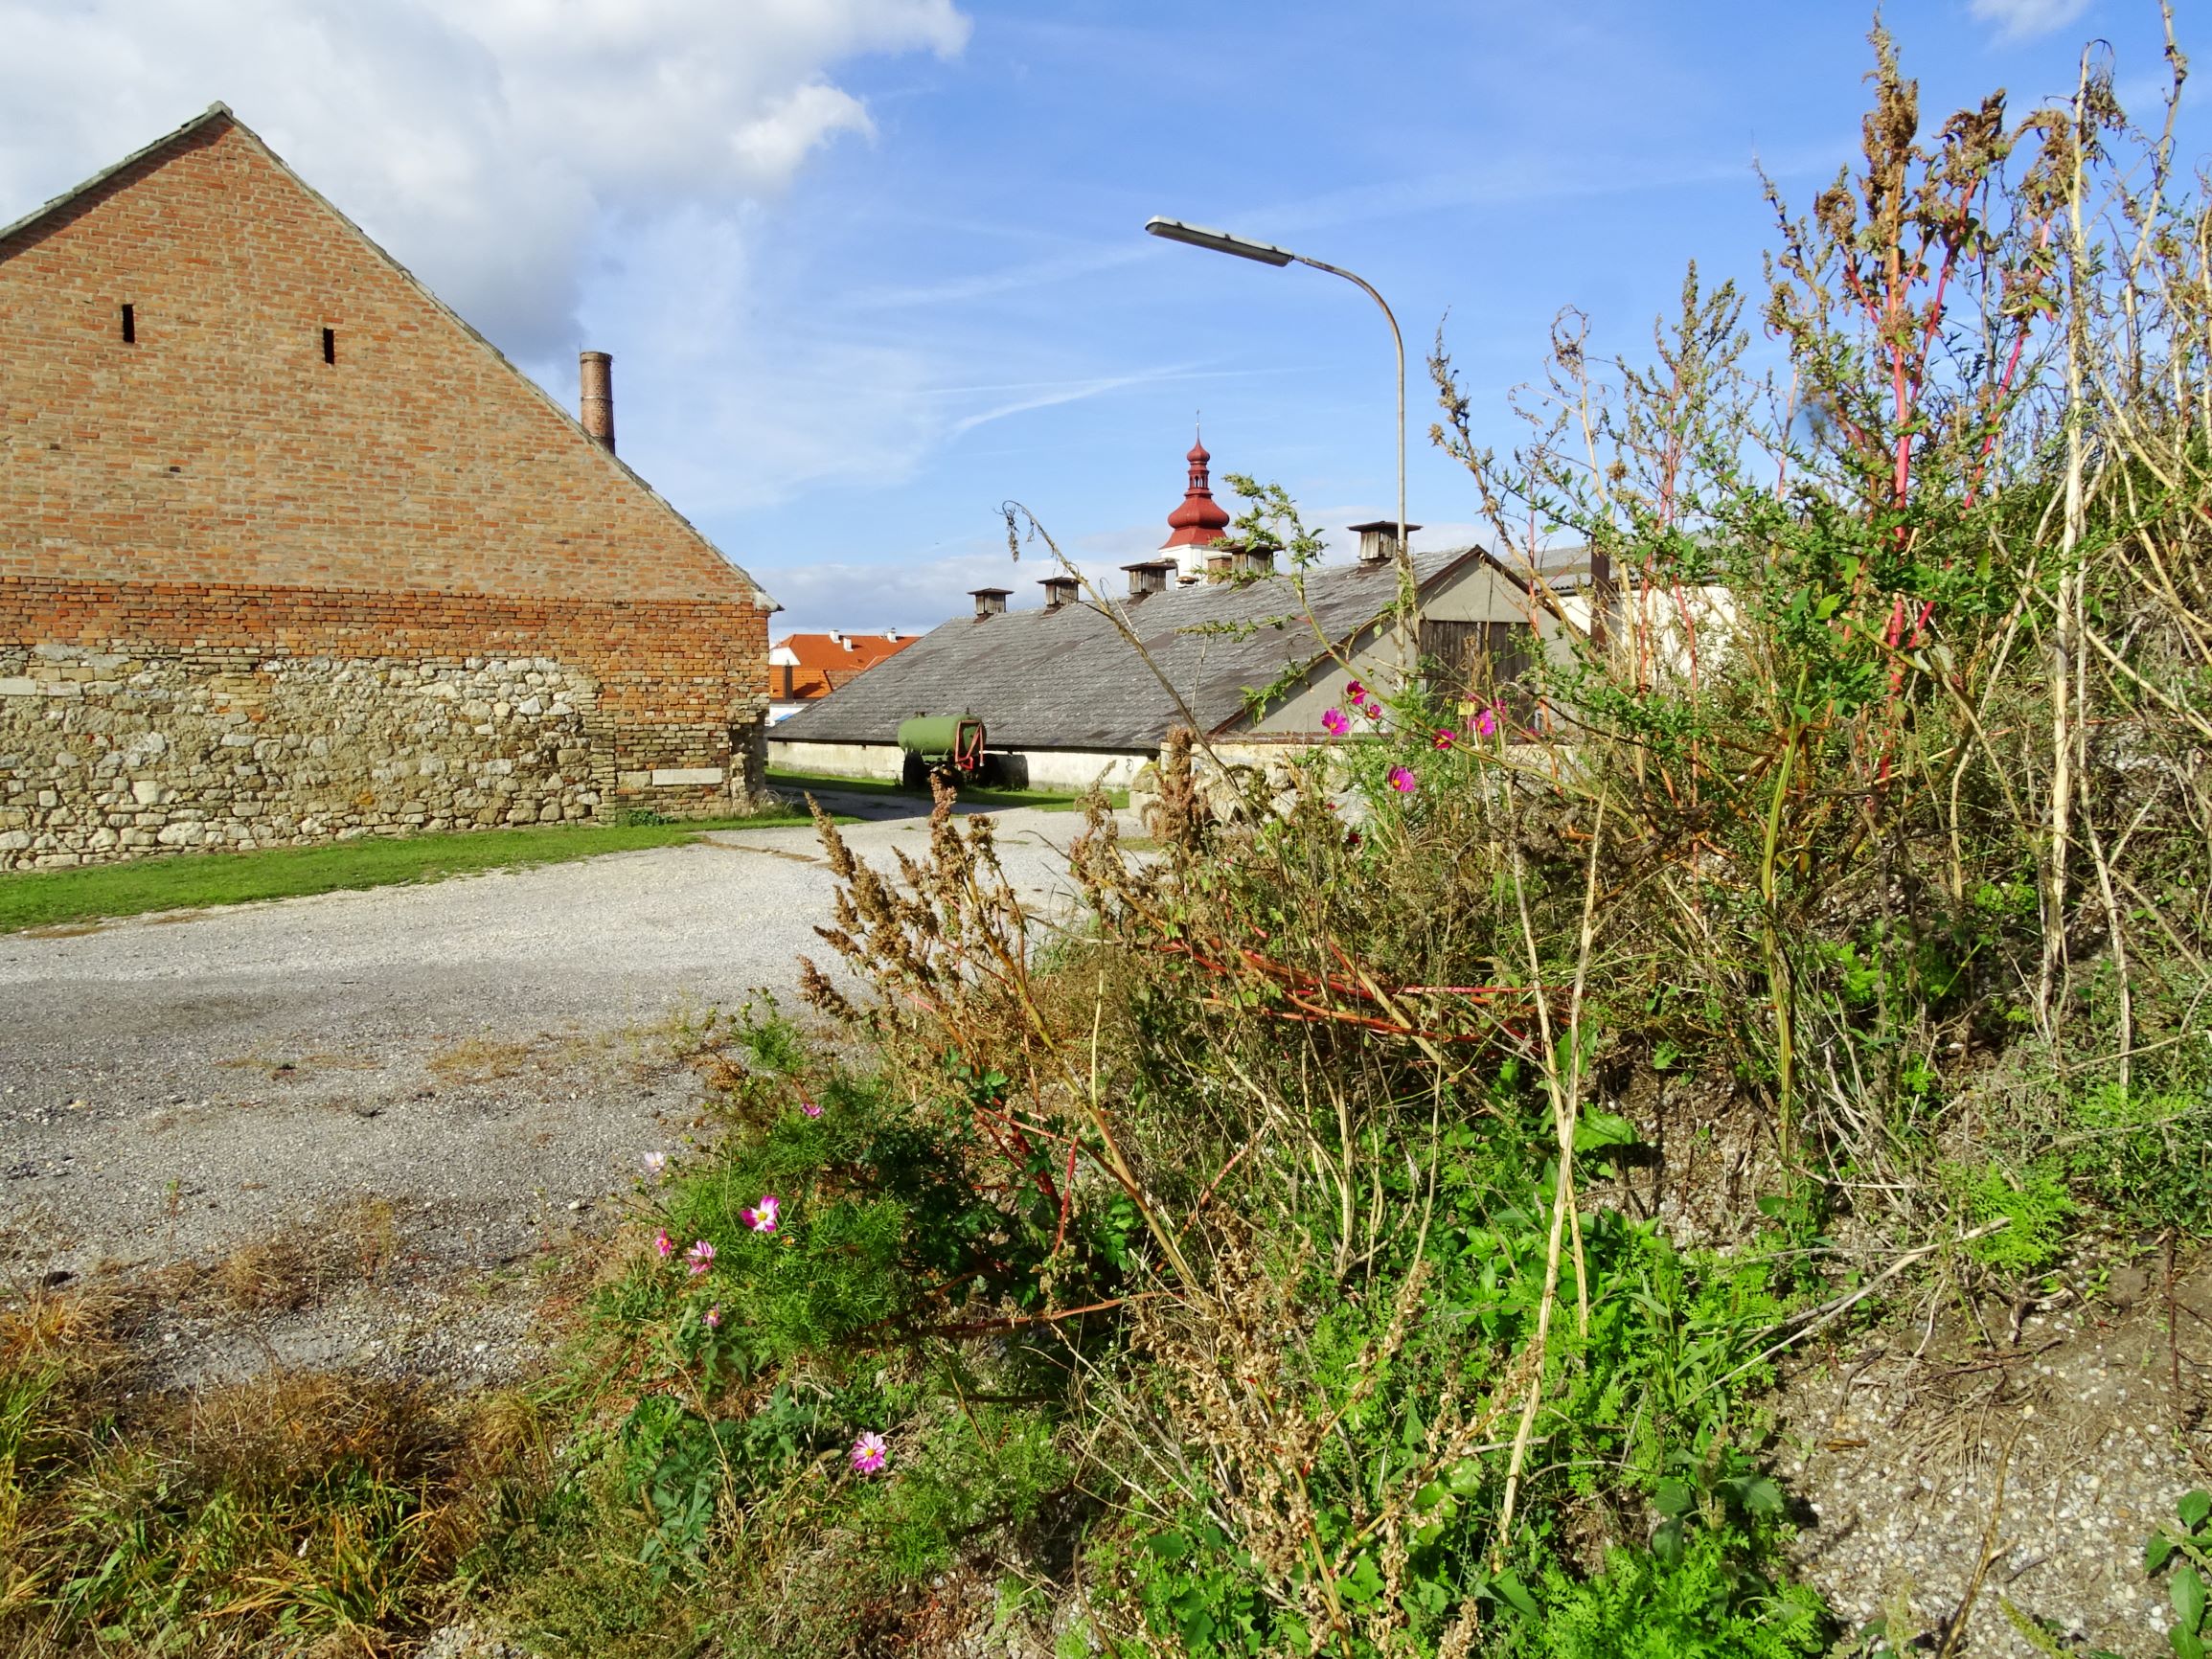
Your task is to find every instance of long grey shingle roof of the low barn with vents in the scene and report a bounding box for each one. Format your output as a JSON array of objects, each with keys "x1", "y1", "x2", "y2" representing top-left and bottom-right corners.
[{"x1": 776, "y1": 549, "x2": 1480, "y2": 750}]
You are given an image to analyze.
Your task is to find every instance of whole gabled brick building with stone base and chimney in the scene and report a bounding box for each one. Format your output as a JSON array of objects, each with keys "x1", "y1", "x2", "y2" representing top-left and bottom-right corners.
[{"x1": 0, "y1": 104, "x2": 774, "y2": 867}]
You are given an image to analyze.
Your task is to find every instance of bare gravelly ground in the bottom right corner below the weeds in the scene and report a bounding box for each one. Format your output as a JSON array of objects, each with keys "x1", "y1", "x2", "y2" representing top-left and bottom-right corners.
[{"x1": 1783, "y1": 1265, "x2": 2212, "y2": 1659}]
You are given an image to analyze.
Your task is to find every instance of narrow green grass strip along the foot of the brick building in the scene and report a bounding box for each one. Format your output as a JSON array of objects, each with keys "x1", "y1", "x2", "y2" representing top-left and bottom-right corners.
[{"x1": 0, "y1": 812, "x2": 808, "y2": 934}]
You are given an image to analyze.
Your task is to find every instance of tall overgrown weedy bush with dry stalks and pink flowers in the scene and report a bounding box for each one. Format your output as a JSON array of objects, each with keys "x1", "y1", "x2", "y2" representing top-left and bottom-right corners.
[{"x1": 457, "y1": 19, "x2": 2212, "y2": 1659}]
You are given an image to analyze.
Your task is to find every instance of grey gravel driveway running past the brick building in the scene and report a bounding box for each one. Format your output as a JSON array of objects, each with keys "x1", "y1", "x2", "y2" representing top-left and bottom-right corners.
[{"x1": 0, "y1": 796, "x2": 1082, "y2": 1371}]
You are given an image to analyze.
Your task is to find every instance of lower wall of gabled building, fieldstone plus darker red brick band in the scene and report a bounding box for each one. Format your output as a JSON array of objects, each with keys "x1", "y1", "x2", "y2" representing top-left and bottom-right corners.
[{"x1": 0, "y1": 578, "x2": 767, "y2": 870}]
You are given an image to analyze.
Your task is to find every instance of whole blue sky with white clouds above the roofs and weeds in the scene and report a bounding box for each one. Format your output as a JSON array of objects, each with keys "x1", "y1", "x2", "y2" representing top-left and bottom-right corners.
[{"x1": 0, "y1": 0, "x2": 2212, "y2": 630}]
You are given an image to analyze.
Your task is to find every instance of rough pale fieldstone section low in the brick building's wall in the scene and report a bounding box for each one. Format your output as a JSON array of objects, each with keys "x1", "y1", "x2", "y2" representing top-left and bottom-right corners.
[{"x1": 0, "y1": 644, "x2": 615, "y2": 867}]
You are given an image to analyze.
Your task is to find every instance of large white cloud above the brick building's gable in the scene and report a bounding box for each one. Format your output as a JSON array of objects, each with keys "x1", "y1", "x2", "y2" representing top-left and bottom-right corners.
[{"x1": 0, "y1": 0, "x2": 969, "y2": 356}]
